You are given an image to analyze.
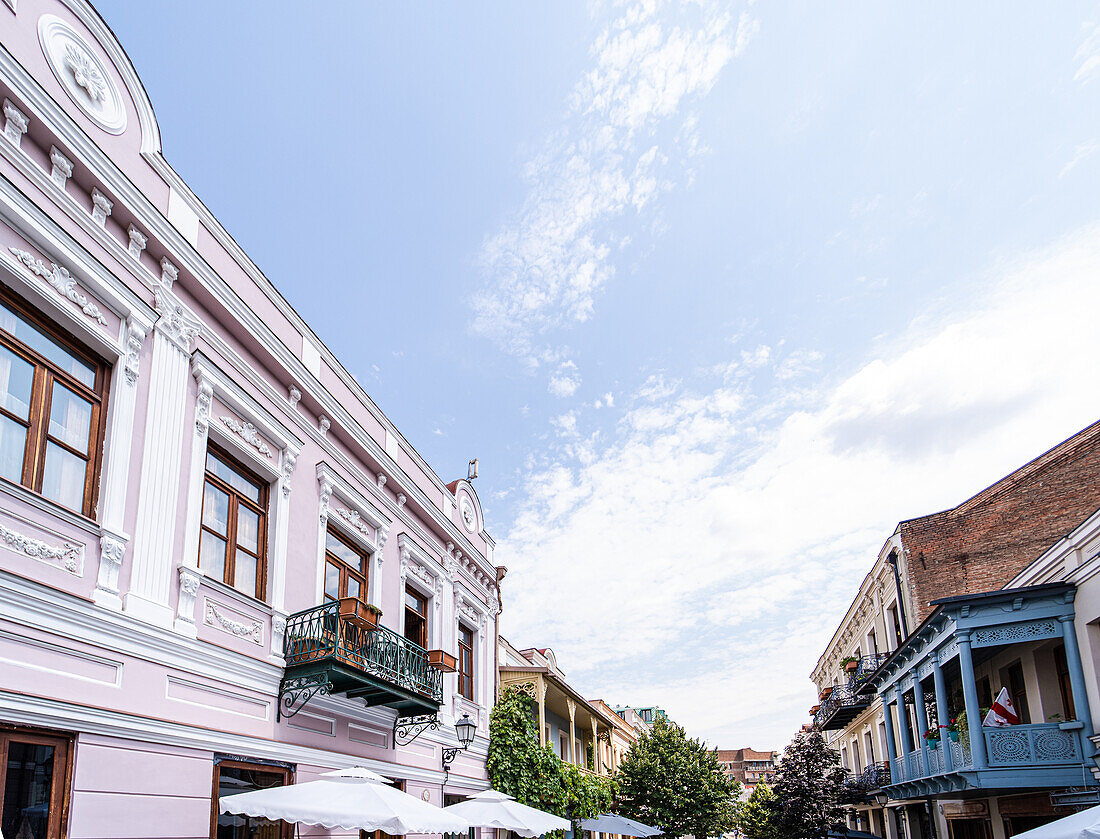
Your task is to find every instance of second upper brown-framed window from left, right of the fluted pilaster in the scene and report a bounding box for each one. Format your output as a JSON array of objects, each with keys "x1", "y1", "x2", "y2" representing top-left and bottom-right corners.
[{"x1": 199, "y1": 445, "x2": 267, "y2": 600}]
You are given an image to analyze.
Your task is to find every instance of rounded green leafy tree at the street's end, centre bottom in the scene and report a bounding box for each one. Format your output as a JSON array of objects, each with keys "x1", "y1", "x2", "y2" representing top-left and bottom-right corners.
[{"x1": 617, "y1": 719, "x2": 739, "y2": 839}]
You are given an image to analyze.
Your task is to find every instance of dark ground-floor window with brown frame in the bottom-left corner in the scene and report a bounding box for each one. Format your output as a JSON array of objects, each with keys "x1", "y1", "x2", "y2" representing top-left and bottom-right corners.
[{"x1": 0, "y1": 731, "x2": 72, "y2": 839}]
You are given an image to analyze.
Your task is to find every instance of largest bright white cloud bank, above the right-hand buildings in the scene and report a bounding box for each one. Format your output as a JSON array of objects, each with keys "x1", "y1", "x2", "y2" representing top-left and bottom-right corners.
[{"x1": 497, "y1": 227, "x2": 1100, "y2": 747}]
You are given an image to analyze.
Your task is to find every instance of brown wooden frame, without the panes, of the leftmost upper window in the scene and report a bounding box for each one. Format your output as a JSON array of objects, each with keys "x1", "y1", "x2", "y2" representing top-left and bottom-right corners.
[{"x1": 0, "y1": 286, "x2": 111, "y2": 520}]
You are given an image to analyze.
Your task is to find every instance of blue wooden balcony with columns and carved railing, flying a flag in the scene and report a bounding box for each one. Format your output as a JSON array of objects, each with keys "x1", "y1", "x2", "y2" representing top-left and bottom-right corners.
[{"x1": 868, "y1": 583, "x2": 1096, "y2": 799}]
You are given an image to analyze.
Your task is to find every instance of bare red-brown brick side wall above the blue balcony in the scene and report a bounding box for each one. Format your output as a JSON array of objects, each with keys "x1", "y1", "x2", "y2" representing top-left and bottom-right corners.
[{"x1": 899, "y1": 422, "x2": 1100, "y2": 631}]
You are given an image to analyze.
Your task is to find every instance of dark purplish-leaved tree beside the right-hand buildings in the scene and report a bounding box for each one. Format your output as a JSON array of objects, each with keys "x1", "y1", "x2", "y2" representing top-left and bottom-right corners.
[{"x1": 772, "y1": 730, "x2": 845, "y2": 839}]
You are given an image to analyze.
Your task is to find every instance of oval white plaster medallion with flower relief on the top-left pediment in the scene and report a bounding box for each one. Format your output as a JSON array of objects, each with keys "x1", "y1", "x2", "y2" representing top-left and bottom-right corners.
[{"x1": 39, "y1": 14, "x2": 127, "y2": 134}]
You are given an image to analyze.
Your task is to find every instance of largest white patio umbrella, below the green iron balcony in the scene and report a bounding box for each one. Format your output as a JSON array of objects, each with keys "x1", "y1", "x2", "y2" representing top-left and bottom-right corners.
[{"x1": 218, "y1": 766, "x2": 471, "y2": 836}]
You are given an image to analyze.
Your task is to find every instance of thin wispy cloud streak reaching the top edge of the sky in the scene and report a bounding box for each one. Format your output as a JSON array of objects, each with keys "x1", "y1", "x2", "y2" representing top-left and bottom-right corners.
[{"x1": 472, "y1": 0, "x2": 758, "y2": 368}]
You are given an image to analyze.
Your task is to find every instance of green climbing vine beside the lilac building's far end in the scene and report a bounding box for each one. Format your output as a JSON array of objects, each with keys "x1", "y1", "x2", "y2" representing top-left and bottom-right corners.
[{"x1": 486, "y1": 687, "x2": 615, "y2": 821}]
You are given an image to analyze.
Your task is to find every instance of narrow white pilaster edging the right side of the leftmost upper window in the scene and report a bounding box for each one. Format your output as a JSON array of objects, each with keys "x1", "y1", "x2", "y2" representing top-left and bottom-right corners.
[{"x1": 92, "y1": 319, "x2": 145, "y2": 609}]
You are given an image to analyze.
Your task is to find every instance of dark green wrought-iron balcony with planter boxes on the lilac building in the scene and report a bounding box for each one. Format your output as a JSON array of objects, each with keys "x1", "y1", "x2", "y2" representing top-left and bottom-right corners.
[{"x1": 279, "y1": 601, "x2": 443, "y2": 717}]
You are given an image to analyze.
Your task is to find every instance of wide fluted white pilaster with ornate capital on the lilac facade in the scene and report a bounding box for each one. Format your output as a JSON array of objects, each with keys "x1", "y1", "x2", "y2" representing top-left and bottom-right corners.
[{"x1": 124, "y1": 286, "x2": 199, "y2": 627}]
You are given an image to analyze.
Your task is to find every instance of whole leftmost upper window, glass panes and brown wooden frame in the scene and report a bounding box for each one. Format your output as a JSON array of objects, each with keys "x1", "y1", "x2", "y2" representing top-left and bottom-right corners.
[{"x1": 0, "y1": 298, "x2": 108, "y2": 517}]
